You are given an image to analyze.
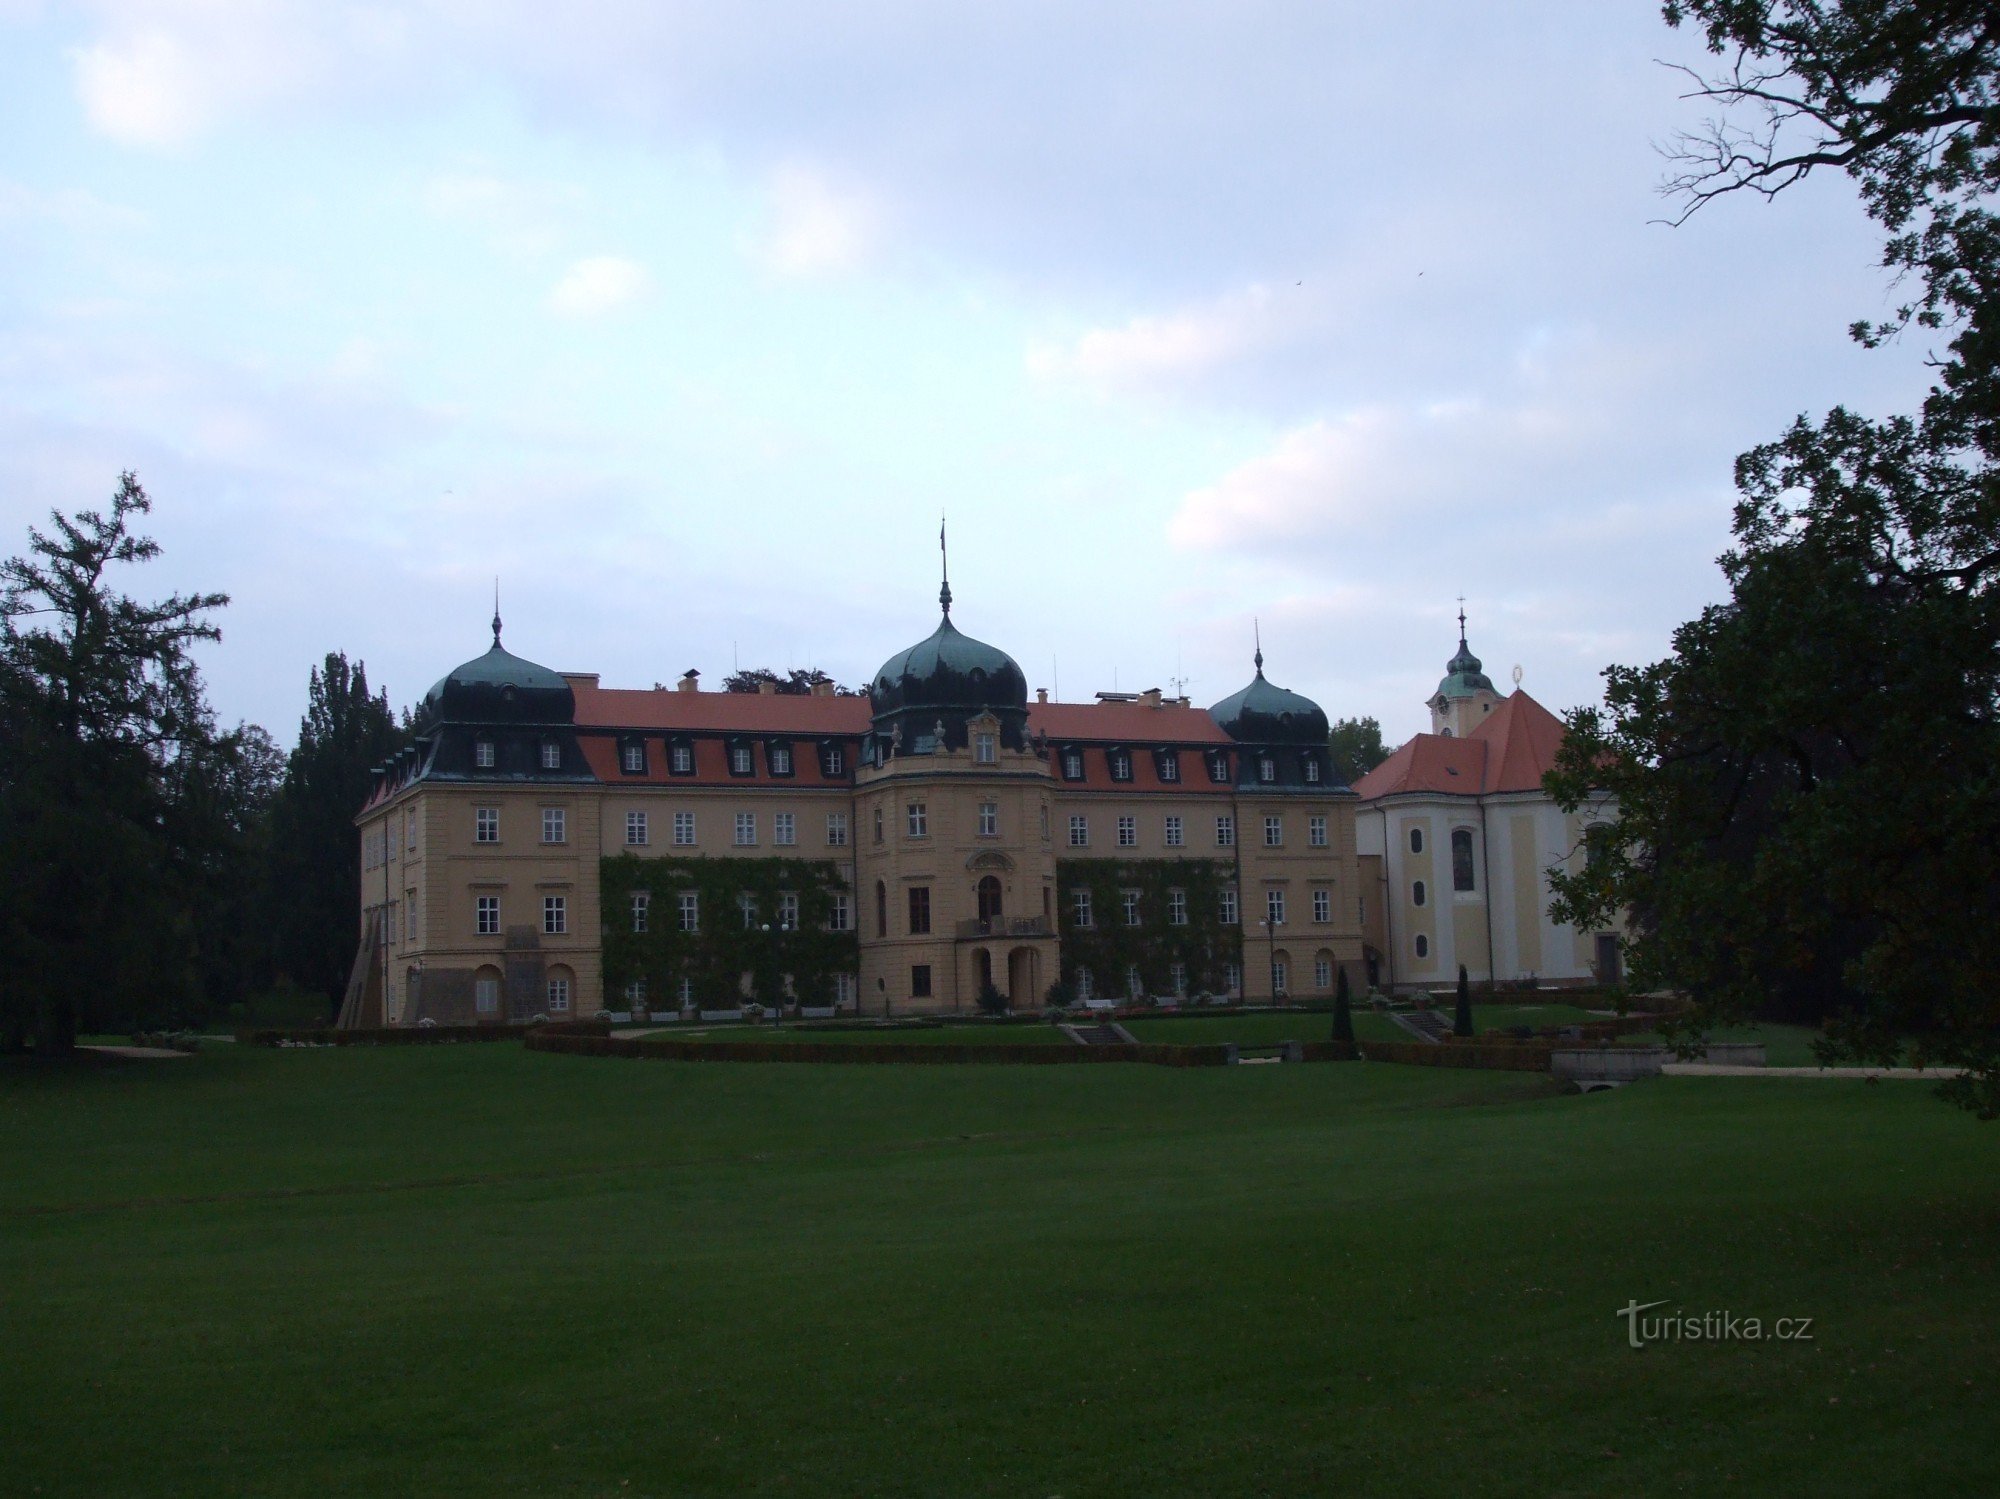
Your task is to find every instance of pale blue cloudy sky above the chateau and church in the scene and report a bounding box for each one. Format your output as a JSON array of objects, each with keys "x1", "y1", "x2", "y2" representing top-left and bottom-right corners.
[{"x1": 0, "y1": 0, "x2": 1922, "y2": 744}]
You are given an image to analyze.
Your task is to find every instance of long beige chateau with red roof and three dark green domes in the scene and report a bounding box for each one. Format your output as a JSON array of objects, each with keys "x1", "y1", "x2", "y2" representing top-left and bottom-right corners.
[{"x1": 342, "y1": 584, "x2": 1376, "y2": 1025}]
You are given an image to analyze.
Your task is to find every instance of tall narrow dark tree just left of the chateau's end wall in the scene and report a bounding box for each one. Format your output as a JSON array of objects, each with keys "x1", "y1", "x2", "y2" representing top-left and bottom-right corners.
[{"x1": 264, "y1": 652, "x2": 410, "y2": 1015}]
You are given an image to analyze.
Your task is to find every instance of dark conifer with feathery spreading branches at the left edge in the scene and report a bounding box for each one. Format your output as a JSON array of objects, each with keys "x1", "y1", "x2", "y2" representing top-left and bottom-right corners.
[{"x1": 0, "y1": 474, "x2": 236, "y2": 1055}]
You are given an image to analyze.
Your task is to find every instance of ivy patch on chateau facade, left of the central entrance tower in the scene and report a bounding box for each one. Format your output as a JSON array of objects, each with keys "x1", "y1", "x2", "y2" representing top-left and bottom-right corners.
[{"x1": 598, "y1": 853, "x2": 860, "y2": 1009}]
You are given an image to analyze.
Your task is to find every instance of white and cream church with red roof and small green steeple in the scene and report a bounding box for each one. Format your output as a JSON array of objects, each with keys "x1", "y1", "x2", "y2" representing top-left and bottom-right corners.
[{"x1": 1354, "y1": 614, "x2": 1622, "y2": 989}]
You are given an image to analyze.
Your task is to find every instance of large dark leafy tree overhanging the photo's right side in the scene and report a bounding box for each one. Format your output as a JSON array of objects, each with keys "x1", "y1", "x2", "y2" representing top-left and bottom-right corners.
[{"x1": 1550, "y1": 0, "x2": 2000, "y2": 1119}]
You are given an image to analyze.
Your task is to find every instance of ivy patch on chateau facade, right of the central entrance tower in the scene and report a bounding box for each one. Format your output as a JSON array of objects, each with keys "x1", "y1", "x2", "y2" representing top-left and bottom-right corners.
[{"x1": 1056, "y1": 859, "x2": 1242, "y2": 995}]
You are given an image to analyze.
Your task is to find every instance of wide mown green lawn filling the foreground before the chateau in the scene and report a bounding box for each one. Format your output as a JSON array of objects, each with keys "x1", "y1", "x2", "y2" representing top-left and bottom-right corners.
[{"x1": 0, "y1": 1047, "x2": 2000, "y2": 1499}]
